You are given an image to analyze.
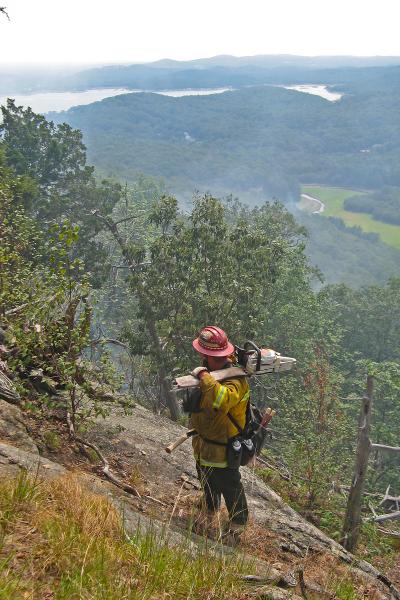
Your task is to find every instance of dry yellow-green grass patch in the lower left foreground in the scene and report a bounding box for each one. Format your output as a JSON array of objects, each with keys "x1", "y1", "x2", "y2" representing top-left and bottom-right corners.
[{"x1": 0, "y1": 473, "x2": 244, "y2": 600}]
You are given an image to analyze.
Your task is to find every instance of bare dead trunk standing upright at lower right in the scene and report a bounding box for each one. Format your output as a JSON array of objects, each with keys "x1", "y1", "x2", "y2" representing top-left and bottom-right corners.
[{"x1": 342, "y1": 375, "x2": 374, "y2": 552}]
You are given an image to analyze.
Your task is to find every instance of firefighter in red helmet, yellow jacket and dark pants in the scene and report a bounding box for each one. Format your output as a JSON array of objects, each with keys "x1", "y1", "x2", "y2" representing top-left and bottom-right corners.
[{"x1": 190, "y1": 326, "x2": 250, "y2": 539}]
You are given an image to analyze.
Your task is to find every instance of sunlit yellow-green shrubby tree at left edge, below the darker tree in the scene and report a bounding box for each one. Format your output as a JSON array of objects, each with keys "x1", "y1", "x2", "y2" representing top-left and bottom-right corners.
[{"x1": 0, "y1": 155, "x2": 119, "y2": 422}]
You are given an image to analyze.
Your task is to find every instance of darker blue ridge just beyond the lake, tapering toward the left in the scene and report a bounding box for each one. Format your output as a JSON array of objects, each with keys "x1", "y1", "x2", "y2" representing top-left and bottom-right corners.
[{"x1": 53, "y1": 56, "x2": 400, "y2": 90}]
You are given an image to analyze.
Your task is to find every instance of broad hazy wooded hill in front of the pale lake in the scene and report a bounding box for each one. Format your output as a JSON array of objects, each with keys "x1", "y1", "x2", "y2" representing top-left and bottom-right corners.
[{"x1": 52, "y1": 67, "x2": 400, "y2": 201}]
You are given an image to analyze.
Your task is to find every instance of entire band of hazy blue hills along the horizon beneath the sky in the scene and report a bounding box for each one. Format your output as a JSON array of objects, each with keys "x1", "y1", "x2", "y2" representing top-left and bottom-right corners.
[{"x1": 0, "y1": 54, "x2": 400, "y2": 95}]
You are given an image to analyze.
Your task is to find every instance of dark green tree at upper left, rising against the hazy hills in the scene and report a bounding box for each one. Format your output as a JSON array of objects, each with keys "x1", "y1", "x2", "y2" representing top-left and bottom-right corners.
[{"x1": 0, "y1": 99, "x2": 123, "y2": 285}]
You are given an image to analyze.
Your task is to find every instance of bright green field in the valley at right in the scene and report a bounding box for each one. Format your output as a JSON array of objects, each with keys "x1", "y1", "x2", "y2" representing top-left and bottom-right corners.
[{"x1": 300, "y1": 186, "x2": 400, "y2": 249}]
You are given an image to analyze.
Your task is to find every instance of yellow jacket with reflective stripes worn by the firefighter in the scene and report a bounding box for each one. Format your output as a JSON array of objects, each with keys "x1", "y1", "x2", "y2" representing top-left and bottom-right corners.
[{"x1": 190, "y1": 373, "x2": 250, "y2": 468}]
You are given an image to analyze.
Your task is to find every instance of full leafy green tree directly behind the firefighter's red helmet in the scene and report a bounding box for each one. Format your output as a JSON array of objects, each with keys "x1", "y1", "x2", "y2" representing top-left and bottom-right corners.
[{"x1": 92, "y1": 195, "x2": 320, "y2": 418}]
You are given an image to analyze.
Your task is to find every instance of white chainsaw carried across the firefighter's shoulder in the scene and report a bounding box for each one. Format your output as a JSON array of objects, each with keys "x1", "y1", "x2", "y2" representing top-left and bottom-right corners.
[{"x1": 172, "y1": 341, "x2": 296, "y2": 391}]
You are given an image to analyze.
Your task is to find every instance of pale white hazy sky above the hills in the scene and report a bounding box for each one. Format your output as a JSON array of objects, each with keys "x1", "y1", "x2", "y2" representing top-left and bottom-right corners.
[{"x1": 0, "y1": 0, "x2": 400, "y2": 63}]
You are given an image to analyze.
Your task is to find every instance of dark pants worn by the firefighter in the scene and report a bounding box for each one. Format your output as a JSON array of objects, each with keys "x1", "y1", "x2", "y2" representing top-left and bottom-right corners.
[{"x1": 196, "y1": 463, "x2": 249, "y2": 525}]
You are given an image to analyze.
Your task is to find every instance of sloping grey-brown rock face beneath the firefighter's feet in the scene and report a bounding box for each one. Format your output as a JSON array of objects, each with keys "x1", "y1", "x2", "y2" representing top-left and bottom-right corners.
[{"x1": 0, "y1": 401, "x2": 400, "y2": 599}]
